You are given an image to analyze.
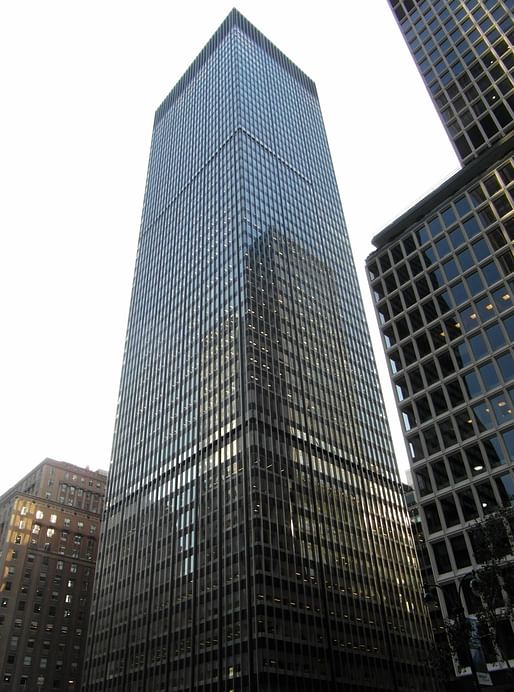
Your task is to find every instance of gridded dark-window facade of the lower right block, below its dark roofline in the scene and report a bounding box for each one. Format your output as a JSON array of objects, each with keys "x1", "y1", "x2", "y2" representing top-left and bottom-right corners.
[{"x1": 368, "y1": 143, "x2": 514, "y2": 592}]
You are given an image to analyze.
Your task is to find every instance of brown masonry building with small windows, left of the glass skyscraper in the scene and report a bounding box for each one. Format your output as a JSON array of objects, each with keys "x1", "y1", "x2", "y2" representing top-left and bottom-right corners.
[{"x1": 0, "y1": 459, "x2": 106, "y2": 692}]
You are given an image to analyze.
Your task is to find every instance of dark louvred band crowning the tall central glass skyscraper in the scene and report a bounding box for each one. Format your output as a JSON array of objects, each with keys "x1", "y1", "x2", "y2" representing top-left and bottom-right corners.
[{"x1": 154, "y1": 8, "x2": 317, "y2": 126}]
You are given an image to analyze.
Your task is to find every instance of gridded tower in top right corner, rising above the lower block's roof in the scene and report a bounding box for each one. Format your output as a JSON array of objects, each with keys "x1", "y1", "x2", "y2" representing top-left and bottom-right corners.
[{"x1": 389, "y1": 0, "x2": 514, "y2": 163}]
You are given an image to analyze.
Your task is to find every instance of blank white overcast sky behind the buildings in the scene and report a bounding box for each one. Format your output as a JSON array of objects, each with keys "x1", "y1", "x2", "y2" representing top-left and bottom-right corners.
[{"x1": 0, "y1": 0, "x2": 457, "y2": 494}]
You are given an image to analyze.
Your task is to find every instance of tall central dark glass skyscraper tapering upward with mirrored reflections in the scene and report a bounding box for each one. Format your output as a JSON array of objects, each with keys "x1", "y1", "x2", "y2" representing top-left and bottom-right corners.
[{"x1": 85, "y1": 11, "x2": 432, "y2": 692}]
